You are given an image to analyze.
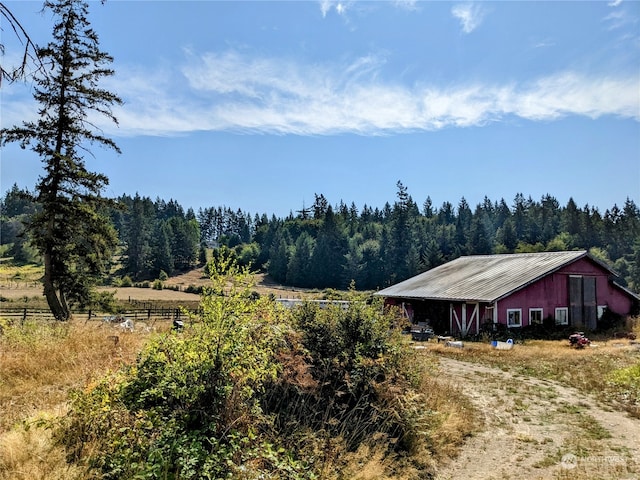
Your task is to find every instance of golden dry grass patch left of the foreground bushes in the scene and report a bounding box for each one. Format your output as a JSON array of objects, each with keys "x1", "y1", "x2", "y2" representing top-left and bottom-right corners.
[{"x1": 0, "y1": 322, "x2": 160, "y2": 480}]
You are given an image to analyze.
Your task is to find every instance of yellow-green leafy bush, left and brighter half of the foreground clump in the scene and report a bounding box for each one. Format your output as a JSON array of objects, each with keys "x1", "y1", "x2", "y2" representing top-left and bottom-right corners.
[{"x1": 60, "y1": 249, "x2": 315, "y2": 479}]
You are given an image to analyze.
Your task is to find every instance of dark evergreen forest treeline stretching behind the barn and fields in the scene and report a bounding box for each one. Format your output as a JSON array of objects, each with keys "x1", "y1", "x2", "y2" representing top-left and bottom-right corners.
[{"x1": 1, "y1": 182, "x2": 640, "y2": 291}]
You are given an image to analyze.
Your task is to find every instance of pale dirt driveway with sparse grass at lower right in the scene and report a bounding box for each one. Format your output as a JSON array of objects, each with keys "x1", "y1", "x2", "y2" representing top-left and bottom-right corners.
[{"x1": 436, "y1": 358, "x2": 640, "y2": 480}]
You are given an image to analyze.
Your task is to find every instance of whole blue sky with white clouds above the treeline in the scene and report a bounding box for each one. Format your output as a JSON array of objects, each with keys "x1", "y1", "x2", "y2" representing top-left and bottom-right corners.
[{"x1": 0, "y1": 0, "x2": 640, "y2": 216}]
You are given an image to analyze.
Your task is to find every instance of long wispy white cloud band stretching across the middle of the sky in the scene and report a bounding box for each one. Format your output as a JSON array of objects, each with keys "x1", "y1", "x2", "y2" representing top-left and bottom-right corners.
[{"x1": 3, "y1": 51, "x2": 640, "y2": 136}]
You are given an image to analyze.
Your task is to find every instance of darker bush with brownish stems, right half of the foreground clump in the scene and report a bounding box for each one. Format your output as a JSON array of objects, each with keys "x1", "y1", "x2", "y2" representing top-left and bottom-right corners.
[{"x1": 269, "y1": 292, "x2": 415, "y2": 450}]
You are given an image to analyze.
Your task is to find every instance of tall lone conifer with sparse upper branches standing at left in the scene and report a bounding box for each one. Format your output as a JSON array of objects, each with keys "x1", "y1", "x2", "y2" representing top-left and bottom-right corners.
[{"x1": 2, "y1": 0, "x2": 121, "y2": 320}]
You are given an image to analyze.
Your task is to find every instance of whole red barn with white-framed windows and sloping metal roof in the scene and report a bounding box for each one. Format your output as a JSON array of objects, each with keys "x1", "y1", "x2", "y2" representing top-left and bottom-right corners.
[{"x1": 377, "y1": 251, "x2": 640, "y2": 337}]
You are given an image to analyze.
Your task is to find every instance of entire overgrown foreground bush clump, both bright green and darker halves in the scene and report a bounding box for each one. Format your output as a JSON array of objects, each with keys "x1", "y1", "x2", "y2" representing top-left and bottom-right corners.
[{"x1": 59, "y1": 255, "x2": 436, "y2": 479}]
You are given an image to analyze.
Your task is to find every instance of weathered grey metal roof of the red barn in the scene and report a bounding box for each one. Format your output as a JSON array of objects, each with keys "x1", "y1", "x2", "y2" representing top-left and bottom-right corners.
[{"x1": 377, "y1": 250, "x2": 599, "y2": 302}]
